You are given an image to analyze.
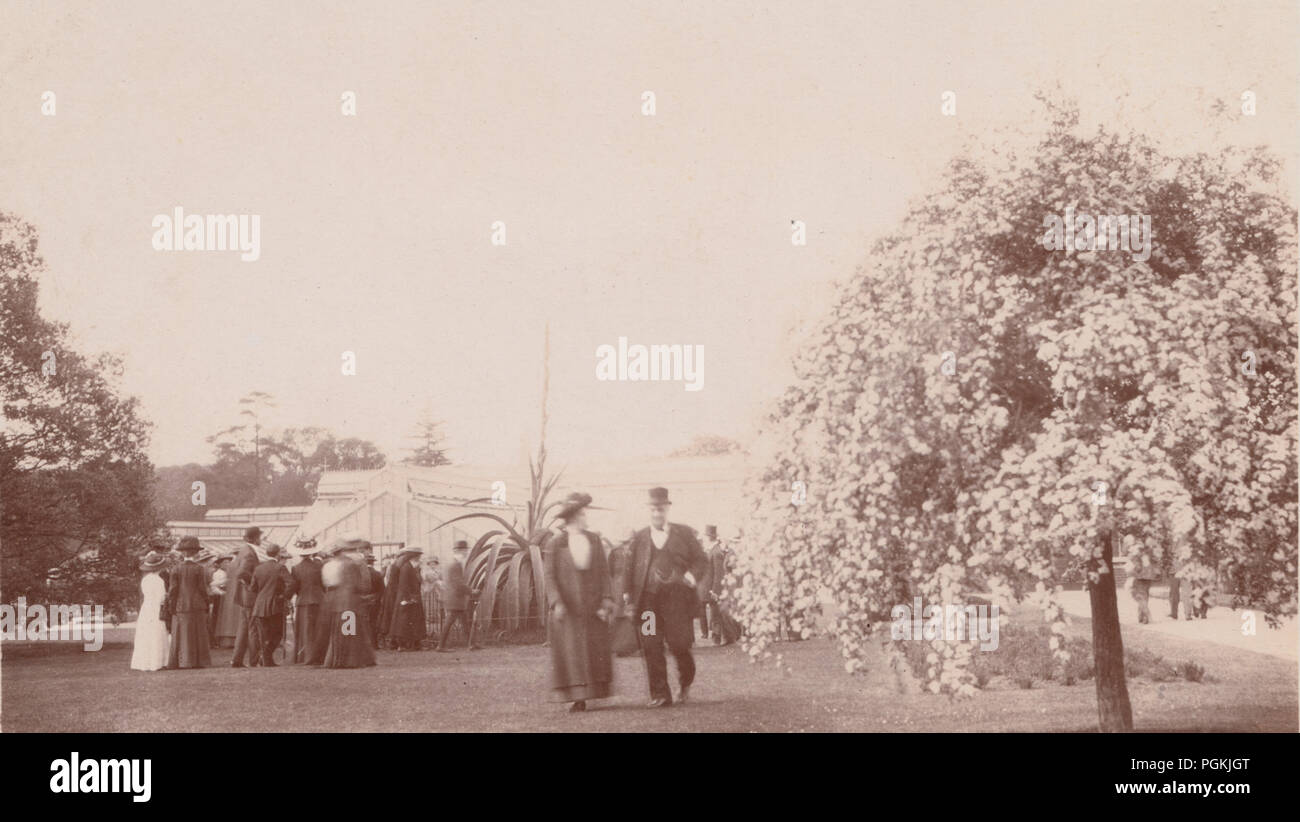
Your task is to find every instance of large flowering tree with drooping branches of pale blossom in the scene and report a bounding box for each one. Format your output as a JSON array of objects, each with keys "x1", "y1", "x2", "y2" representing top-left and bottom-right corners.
[{"x1": 732, "y1": 104, "x2": 1297, "y2": 730}]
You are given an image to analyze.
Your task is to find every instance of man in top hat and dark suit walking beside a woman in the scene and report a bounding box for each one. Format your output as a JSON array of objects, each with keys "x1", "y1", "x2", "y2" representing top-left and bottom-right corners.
[{"x1": 619, "y1": 488, "x2": 709, "y2": 708}]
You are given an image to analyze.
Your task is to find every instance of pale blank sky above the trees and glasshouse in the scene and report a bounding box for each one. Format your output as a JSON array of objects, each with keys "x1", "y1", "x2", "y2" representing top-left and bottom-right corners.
[{"x1": 0, "y1": 0, "x2": 1300, "y2": 464}]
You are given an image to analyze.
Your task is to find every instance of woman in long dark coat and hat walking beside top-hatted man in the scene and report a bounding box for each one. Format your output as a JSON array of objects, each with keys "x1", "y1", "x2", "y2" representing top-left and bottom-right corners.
[{"x1": 542, "y1": 493, "x2": 615, "y2": 711}]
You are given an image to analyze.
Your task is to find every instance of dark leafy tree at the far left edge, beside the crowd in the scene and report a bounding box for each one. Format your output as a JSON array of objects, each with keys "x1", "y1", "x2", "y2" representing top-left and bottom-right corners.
[{"x1": 0, "y1": 213, "x2": 159, "y2": 613}]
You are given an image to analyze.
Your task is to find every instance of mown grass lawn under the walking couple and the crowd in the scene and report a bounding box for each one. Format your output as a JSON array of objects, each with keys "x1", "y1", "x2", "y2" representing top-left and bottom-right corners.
[{"x1": 0, "y1": 620, "x2": 1297, "y2": 732}]
